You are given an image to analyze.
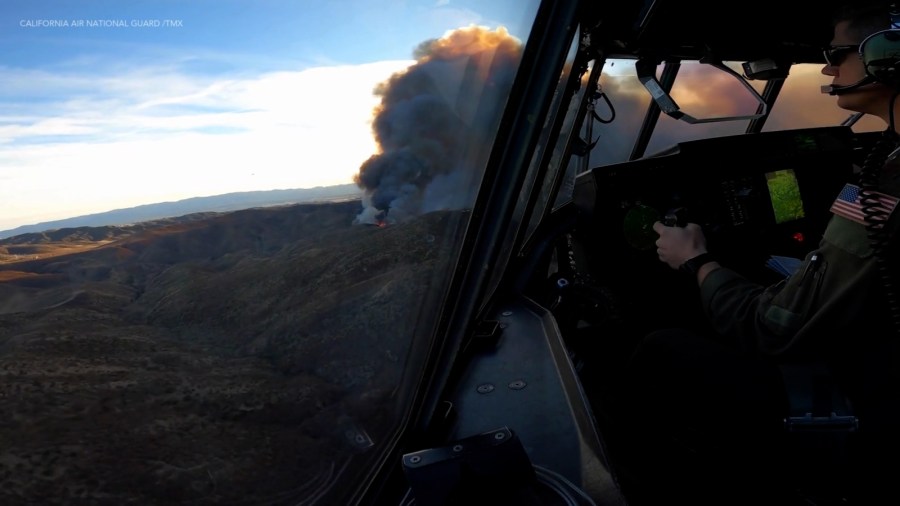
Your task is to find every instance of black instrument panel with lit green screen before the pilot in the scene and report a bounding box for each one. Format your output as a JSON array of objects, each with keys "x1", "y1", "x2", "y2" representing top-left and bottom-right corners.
[{"x1": 574, "y1": 126, "x2": 854, "y2": 328}]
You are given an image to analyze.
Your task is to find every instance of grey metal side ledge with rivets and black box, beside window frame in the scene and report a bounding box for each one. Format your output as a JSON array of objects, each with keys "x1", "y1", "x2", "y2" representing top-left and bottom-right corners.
[{"x1": 403, "y1": 298, "x2": 626, "y2": 506}]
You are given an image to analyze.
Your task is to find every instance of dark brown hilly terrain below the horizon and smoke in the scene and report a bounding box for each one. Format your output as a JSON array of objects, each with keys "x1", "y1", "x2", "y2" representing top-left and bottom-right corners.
[{"x1": 0, "y1": 202, "x2": 465, "y2": 505}]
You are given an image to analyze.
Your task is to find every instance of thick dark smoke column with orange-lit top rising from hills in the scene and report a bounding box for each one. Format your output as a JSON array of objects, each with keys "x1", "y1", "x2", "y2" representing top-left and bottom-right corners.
[{"x1": 354, "y1": 26, "x2": 521, "y2": 224}]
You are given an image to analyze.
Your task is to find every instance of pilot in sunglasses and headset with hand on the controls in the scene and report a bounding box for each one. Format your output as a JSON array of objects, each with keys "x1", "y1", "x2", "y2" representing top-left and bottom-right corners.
[{"x1": 624, "y1": 1, "x2": 900, "y2": 504}]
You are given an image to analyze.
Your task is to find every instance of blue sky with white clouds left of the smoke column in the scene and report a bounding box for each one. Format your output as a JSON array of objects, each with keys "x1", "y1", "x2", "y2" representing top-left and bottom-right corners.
[{"x1": 0, "y1": 0, "x2": 536, "y2": 230}]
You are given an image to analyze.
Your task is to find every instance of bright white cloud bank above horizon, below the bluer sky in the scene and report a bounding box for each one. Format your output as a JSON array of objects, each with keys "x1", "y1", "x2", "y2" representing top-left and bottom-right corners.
[{"x1": 0, "y1": 61, "x2": 412, "y2": 230}]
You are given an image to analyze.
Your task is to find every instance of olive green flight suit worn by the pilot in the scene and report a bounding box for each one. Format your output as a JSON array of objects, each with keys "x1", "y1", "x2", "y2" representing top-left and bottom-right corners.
[{"x1": 700, "y1": 150, "x2": 900, "y2": 359}]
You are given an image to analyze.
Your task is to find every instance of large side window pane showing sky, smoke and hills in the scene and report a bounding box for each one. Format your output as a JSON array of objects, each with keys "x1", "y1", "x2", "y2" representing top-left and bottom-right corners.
[{"x1": 0, "y1": 0, "x2": 538, "y2": 505}]
